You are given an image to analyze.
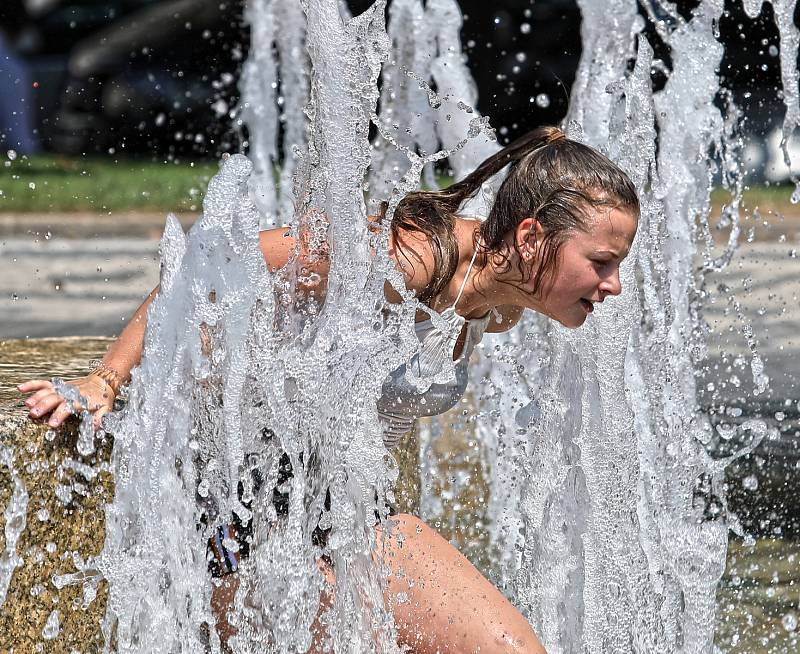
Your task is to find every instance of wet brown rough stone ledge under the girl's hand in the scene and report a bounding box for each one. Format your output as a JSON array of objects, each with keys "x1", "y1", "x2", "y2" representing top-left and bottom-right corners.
[{"x1": 0, "y1": 416, "x2": 113, "y2": 654}]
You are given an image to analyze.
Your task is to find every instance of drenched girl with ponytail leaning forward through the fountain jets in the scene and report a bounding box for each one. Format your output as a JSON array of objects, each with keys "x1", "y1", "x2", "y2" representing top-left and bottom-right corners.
[{"x1": 19, "y1": 127, "x2": 639, "y2": 654}]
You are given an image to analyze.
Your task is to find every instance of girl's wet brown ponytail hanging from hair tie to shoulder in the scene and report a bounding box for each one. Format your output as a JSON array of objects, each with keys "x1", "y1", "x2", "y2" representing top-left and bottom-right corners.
[{"x1": 384, "y1": 127, "x2": 566, "y2": 302}]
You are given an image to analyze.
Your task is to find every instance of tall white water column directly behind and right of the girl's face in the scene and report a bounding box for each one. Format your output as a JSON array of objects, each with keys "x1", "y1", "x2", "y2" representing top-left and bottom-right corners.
[{"x1": 506, "y1": 1, "x2": 776, "y2": 652}]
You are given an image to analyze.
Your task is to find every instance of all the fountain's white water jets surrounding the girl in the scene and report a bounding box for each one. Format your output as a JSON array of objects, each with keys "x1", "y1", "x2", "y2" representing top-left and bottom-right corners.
[{"x1": 0, "y1": 0, "x2": 800, "y2": 654}]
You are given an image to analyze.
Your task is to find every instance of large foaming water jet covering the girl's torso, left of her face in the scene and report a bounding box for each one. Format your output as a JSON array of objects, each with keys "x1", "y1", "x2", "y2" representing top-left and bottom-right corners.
[{"x1": 97, "y1": 2, "x2": 406, "y2": 652}]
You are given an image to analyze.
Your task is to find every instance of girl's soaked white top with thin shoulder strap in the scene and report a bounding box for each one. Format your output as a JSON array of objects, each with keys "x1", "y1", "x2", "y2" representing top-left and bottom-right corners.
[{"x1": 378, "y1": 248, "x2": 491, "y2": 448}]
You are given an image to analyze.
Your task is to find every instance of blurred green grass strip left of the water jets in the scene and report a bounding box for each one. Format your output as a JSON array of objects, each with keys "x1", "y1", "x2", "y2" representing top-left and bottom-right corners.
[{"x1": 0, "y1": 156, "x2": 217, "y2": 213}]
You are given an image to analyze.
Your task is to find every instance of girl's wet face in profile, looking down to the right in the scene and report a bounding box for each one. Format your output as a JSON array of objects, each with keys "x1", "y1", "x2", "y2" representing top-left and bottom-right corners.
[{"x1": 530, "y1": 207, "x2": 637, "y2": 327}]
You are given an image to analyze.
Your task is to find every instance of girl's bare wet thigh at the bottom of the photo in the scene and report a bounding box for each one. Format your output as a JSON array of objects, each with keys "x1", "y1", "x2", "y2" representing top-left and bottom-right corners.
[{"x1": 380, "y1": 514, "x2": 544, "y2": 654}]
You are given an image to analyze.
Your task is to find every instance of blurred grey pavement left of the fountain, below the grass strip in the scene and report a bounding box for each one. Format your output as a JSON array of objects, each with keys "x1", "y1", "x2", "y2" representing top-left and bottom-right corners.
[{"x1": 0, "y1": 214, "x2": 189, "y2": 339}]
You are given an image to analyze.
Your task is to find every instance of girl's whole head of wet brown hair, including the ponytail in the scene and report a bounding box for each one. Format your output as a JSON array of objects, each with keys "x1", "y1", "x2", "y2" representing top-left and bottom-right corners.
[{"x1": 390, "y1": 127, "x2": 639, "y2": 302}]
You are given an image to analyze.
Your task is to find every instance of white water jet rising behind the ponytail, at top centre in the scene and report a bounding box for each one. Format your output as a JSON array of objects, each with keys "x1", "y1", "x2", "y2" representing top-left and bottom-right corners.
[{"x1": 370, "y1": 0, "x2": 501, "y2": 216}]
